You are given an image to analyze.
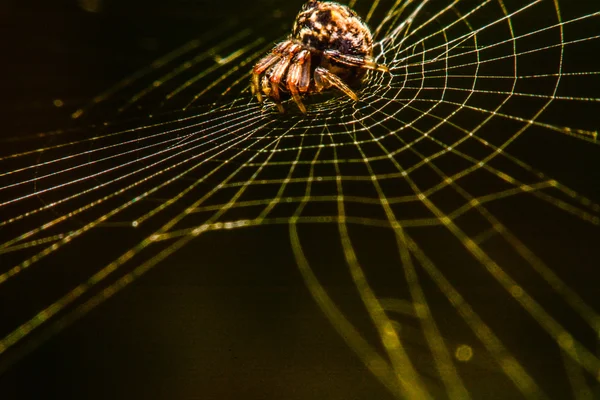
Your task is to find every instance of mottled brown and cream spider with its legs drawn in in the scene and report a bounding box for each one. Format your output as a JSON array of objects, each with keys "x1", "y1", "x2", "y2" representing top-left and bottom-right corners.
[{"x1": 251, "y1": 0, "x2": 389, "y2": 114}]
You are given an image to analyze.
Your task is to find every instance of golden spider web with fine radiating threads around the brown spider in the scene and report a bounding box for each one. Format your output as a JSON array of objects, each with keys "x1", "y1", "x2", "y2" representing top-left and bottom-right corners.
[{"x1": 0, "y1": 0, "x2": 600, "y2": 399}]
